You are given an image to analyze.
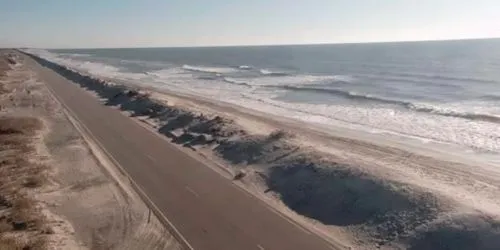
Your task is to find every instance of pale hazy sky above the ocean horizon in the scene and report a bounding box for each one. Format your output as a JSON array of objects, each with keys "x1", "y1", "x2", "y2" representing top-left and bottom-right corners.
[{"x1": 0, "y1": 0, "x2": 500, "y2": 48}]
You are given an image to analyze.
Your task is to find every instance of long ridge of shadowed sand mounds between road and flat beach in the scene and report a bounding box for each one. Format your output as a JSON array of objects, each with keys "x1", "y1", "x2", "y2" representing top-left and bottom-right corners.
[{"x1": 26, "y1": 52, "x2": 499, "y2": 249}]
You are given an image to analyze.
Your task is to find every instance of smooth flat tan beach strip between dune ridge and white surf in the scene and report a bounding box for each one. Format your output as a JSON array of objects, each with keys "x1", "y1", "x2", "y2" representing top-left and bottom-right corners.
[{"x1": 135, "y1": 78, "x2": 500, "y2": 168}]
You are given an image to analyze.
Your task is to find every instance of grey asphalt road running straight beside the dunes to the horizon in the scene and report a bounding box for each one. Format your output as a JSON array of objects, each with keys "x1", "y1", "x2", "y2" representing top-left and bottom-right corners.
[{"x1": 26, "y1": 53, "x2": 335, "y2": 250}]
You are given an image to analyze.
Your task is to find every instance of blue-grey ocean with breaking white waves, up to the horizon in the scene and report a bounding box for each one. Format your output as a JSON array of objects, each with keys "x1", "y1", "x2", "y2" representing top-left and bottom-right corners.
[{"x1": 31, "y1": 39, "x2": 500, "y2": 154}]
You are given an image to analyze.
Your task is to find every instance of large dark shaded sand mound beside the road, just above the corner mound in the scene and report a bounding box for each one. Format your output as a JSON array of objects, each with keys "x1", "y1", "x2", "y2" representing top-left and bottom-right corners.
[{"x1": 268, "y1": 156, "x2": 438, "y2": 229}]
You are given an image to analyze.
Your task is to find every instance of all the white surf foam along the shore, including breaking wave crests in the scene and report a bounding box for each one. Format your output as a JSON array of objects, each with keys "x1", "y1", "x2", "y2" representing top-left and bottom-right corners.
[{"x1": 26, "y1": 48, "x2": 500, "y2": 152}]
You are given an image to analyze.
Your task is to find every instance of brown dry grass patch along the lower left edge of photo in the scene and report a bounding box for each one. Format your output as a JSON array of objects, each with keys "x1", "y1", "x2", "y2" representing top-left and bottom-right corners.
[{"x1": 0, "y1": 114, "x2": 51, "y2": 250}]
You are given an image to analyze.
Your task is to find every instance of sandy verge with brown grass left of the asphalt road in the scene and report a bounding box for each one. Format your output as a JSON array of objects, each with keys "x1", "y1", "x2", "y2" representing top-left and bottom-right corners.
[{"x1": 0, "y1": 50, "x2": 180, "y2": 249}]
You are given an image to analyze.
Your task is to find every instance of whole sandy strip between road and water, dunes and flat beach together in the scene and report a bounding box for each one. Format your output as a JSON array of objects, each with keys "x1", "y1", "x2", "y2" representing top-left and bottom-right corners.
[{"x1": 28, "y1": 52, "x2": 500, "y2": 249}]
